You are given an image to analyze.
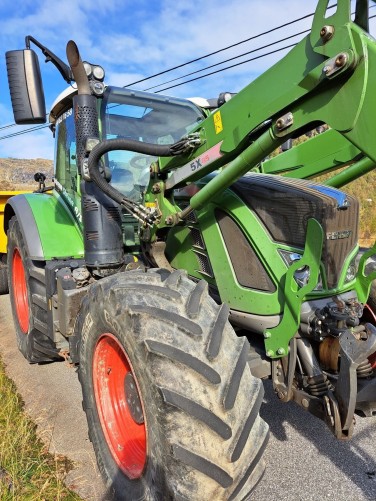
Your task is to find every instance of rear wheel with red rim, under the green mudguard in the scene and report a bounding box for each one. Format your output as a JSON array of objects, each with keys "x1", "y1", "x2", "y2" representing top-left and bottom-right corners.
[{"x1": 7, "y1": 216, "x2": 62, "y2": 363}]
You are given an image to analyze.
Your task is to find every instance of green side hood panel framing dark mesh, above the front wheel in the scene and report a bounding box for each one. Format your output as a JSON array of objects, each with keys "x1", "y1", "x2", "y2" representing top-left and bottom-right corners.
[{"x1": 166, "y1": 190, "x2": 287, "y2": 315}]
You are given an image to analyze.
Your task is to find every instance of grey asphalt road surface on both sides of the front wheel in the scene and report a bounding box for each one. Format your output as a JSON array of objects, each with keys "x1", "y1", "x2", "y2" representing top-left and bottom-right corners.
[{"x1": 0, "y1": 296, "x2": 376, "y2": 501}]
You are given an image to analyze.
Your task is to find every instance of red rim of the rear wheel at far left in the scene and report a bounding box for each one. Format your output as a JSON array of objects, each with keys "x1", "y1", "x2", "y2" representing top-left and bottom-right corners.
[{"x1": 12, "y1": 249, "x2": 29, "y2": 334}]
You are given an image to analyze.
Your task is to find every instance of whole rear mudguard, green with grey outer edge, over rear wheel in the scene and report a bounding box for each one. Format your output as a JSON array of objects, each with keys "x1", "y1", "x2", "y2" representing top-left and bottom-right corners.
[{"x1": 4, "y1": 191, "x2": 84, "y2": 261}]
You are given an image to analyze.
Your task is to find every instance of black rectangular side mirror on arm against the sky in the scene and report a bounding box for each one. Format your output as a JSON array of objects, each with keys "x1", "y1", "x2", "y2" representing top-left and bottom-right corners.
[{"x1": 5, "y1": 49, "x2": 46, "y2": 125}]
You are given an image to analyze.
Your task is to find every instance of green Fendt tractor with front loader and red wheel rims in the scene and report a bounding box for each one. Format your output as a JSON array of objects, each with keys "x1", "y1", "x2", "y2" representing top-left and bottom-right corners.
[{"x1": 4, "y1": 0, "x2": 376, "y2": 501}]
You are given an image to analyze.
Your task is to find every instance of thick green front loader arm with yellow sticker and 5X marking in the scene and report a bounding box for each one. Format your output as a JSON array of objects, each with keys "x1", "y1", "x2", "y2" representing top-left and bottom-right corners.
[{"x1": 160, "y1": 0, "x2": 376, "y2": 205}]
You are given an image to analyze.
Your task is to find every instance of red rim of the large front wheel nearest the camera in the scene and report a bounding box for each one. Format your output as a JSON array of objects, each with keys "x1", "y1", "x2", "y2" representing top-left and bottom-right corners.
[{"x1": 93, "y1": 334, "x2": 147, "y2": 479}]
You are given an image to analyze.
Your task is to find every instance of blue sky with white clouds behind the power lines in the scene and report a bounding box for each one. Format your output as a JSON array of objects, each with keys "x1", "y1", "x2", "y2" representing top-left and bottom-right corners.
[{"x1": 0, "y1": 0, "x2": 376, "y2": 159}]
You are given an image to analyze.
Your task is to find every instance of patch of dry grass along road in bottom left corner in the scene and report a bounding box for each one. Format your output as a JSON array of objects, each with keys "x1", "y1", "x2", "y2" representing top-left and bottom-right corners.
[{"x1": 0, "y1": 358, "x2": 81, "y2": 501}]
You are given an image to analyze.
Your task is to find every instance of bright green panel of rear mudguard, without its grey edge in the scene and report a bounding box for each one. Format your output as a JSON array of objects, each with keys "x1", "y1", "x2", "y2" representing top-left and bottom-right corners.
[{"x1": 25, "y1": 191, "x2": 84, "y2": 260}]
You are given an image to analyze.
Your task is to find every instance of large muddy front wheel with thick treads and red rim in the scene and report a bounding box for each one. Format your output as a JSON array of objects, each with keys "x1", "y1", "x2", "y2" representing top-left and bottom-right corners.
[{"x1": 76, "y1": 270, "x2": 268, "y2": 501}]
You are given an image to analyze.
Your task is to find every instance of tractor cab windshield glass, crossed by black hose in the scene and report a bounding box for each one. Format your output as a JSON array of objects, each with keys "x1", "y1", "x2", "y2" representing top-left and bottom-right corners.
[{"x1": 101, "y1": 87, "x2": 205, "y2": 201}]
